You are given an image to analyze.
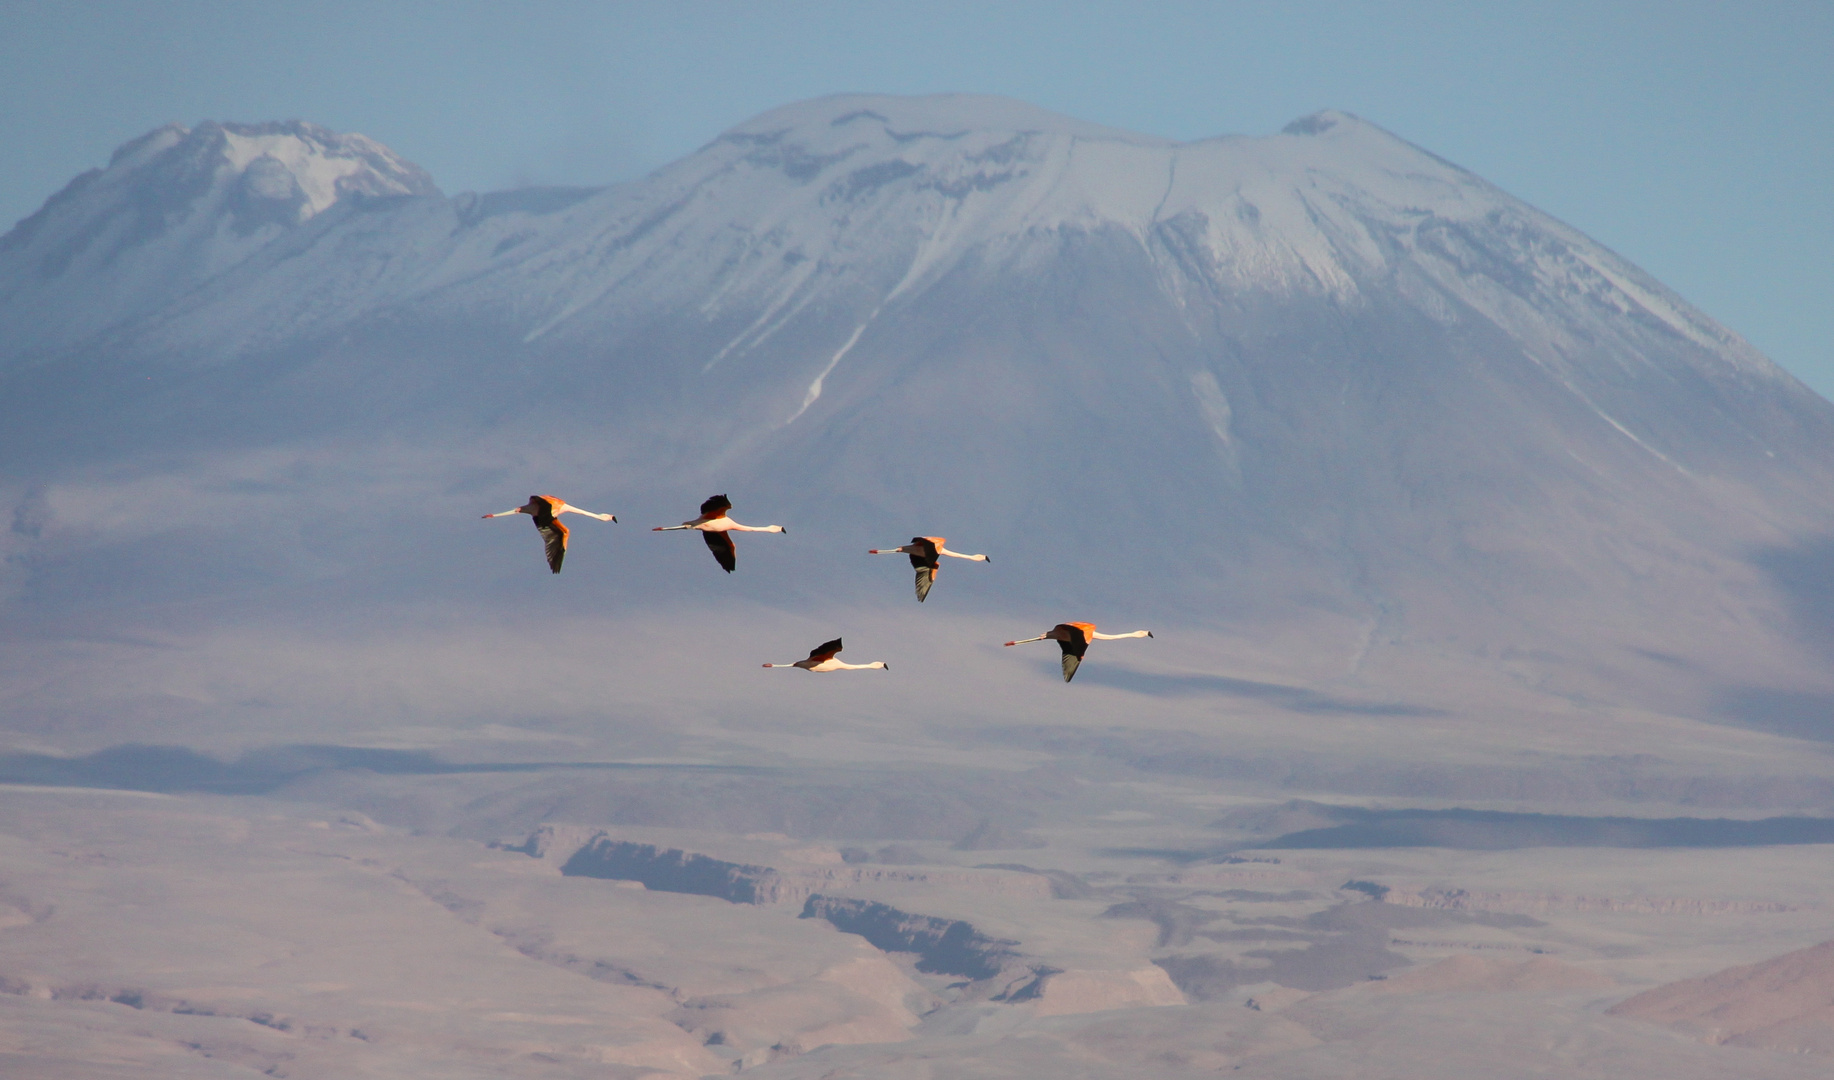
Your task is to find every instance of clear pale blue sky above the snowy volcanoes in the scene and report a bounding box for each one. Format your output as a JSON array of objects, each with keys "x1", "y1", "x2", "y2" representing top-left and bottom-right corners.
[{"x1": 0, "y1": 0, "x2": 1834, "y2": 396}]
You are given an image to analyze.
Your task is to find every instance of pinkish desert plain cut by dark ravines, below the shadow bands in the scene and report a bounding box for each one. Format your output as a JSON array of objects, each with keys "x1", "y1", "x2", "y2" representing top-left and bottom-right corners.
[{"x1": 0, "y1": 781, "x2": 1834, "y2": 1080}]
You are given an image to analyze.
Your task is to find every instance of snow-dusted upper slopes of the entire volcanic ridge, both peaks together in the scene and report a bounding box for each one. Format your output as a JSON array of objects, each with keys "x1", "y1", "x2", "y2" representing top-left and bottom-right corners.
[{"x1": 39, "y1": 95, "x2": 1790, "y2": 453}]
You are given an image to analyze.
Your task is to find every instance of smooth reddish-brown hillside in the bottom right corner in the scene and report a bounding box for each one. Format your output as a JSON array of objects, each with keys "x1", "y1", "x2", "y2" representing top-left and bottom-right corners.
[{"x1": 1608, "y1": 941, "x2": 1834, "y2": 1054}]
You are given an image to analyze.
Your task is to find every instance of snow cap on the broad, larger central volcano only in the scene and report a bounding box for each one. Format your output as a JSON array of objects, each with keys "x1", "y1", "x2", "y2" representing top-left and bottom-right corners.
[{"x1": 429, "y1": 95, "x2": 1786, "y2": 399}]
